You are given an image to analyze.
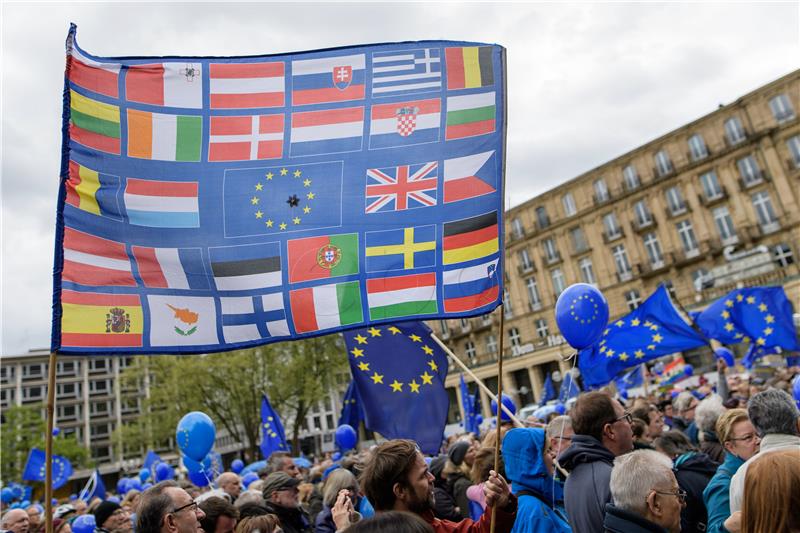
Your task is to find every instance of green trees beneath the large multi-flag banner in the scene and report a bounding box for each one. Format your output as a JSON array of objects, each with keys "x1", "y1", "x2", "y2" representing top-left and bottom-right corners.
[{"x1": 114, "y1": 335, "x2": 347, "y2": 460}]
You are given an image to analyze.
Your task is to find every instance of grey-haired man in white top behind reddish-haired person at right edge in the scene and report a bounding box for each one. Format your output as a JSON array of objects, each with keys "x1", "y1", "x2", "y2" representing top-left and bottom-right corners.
[{"x1": 726, "y1": 389, "x2": 800, "y2": 512}]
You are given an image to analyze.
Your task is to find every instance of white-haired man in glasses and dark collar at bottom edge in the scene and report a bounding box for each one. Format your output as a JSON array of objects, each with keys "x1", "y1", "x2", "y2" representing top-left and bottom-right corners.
[{"x1": 603, "y1": 450, "x2": 686, "y2": 533}]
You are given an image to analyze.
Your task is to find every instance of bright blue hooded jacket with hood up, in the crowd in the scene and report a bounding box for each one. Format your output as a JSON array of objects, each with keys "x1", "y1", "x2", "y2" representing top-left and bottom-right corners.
[{"x1": 503, "y1": 428, "x2": 572, "y2": 533}]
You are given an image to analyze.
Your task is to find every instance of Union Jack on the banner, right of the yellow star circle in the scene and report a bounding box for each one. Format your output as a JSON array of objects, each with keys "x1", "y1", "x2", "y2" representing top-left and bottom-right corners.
[{"x1": 366, "y1": 161, "x2": 439, "y2": 213}]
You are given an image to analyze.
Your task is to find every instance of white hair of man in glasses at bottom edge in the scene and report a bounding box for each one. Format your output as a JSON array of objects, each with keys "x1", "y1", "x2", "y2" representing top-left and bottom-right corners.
[{"x1": 610, "y1": 450, "x2": 675, "y2": 515}]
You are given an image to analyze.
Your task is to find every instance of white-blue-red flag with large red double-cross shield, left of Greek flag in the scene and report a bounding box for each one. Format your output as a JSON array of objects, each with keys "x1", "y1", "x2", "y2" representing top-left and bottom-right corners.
[{"x1": 292, "y1": 54, "x2": 366, "y2": 105}]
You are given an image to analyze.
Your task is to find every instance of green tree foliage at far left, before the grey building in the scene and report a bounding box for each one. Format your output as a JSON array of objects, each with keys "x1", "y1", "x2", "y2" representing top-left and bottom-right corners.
[{"x1": 0, "y1": 404, "x2": 92, "y2": 481}]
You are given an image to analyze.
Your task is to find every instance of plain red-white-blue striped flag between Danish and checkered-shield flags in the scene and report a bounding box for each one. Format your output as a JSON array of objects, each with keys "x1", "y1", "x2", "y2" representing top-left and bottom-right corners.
[{"x1": 290, "y1": 107, "x2": 364, "y2": 157}]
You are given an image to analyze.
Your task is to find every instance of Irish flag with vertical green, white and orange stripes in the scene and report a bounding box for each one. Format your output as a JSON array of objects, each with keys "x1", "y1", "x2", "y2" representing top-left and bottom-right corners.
[{"x1": 128, "y1": 109, "x2": 203, "y2": 161}]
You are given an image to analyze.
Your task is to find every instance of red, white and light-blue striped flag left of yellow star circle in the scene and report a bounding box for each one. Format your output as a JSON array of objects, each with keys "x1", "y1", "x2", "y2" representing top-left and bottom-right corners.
[{"x1": 124, "y1": 178, "x2": 200, "y2": 228}]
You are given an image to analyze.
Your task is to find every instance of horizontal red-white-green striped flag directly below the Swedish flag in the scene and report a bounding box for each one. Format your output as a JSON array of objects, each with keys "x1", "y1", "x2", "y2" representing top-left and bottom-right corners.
[{"x1": 367, "y1": 272, "x2": 439, "y2": 320}]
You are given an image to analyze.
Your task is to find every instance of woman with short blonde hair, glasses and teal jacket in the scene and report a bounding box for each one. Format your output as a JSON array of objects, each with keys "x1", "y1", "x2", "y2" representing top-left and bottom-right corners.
[{"x1": 703, "y1": 409, "x2": 759, "y2": 533}]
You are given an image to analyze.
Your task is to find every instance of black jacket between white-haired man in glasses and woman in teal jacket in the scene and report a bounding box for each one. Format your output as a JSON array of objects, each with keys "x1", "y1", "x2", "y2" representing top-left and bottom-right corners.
[{"x1": 673, "y1": 452, "x2": 719, "y2": 533}]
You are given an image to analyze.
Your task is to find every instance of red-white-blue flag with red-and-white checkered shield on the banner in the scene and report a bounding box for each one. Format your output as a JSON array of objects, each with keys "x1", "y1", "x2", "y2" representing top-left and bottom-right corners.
[{"x1": 369, "y1": 98, "x2": 442, "y2": 149}]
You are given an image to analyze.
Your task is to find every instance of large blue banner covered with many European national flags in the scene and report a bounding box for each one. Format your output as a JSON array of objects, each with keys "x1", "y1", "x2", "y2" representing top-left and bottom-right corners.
[{"x1": 51, "y1": 25, "x2": 506, "y2": 355}]
